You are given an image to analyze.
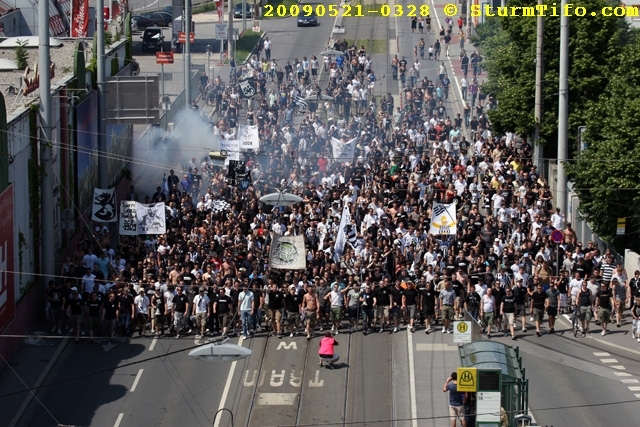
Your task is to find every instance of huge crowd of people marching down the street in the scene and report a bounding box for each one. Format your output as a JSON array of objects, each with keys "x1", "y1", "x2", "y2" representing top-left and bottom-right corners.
[{"x1": 48, "y1": 28, "x2": 640, "y2": 350}]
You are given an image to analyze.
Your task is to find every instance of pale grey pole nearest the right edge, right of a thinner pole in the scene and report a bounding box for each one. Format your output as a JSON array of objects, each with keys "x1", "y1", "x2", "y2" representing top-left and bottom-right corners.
[{"x1": 556, "y1": 0, "x2": 569, "y2": 215}]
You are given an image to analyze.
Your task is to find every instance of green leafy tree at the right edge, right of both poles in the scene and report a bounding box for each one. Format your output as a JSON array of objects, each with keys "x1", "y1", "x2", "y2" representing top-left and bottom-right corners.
[{"x1": 567, "y1": 30, "x2": 640, "y2": 252}]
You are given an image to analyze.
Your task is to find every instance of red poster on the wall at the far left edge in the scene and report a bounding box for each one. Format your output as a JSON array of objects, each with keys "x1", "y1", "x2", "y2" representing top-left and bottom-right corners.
[{"x1": 0, "y1": 185, "x2": 16, "y2": 332}]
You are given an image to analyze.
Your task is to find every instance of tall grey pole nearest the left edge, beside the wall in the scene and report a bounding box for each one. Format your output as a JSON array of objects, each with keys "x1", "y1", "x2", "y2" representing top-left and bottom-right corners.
[{"x1": 35, "y1": 1, "x2": 56, "y2": 289}]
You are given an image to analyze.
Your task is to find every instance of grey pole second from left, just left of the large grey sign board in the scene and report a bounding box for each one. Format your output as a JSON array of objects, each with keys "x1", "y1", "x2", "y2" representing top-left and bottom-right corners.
[{"x1": 93, "y1": 0, "x2": 109, "y2": 188}]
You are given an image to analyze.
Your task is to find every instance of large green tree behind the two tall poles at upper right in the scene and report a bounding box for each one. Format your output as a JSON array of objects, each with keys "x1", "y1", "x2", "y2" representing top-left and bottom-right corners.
[{"x1": 472, "y1": 0, "x2": 629, "y2": 157}]
